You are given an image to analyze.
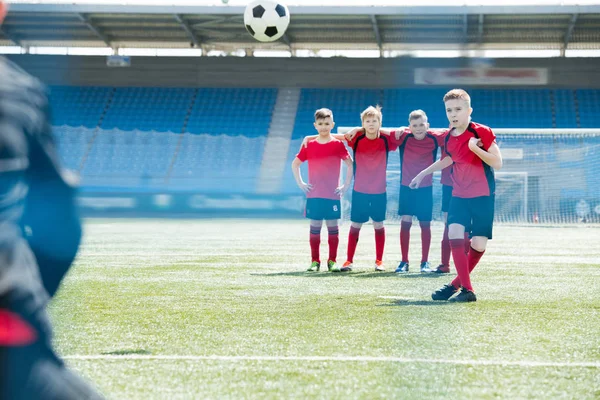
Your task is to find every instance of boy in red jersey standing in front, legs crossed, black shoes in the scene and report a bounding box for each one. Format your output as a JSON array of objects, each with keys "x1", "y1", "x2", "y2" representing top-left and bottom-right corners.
[{"x1": 410, "y1": 89, "x2": 502, "y2": 302}]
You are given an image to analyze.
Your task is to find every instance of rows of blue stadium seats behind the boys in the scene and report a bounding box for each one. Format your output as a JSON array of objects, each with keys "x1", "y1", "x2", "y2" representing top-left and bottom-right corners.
[{"x1": 51, "y1": 87, "x2": 600, "y2": 212}]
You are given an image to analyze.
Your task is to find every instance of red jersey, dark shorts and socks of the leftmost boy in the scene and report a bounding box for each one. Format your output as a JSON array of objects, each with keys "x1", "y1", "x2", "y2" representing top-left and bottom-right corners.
[{"x1": 296, "y1": 138, "x2": 350, "y2": 271}]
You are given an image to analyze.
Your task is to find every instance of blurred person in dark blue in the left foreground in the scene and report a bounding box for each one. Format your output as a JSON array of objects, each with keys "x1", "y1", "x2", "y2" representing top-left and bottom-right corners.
[{"x1": 0, "y1": 0, "x2": 101, "y2": 399}]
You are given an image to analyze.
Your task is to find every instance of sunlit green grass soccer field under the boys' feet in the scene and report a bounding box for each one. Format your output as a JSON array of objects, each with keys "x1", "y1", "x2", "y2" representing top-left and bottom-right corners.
[{"x1": 50, "y1": 220, "x2": 600, "y2": 399}]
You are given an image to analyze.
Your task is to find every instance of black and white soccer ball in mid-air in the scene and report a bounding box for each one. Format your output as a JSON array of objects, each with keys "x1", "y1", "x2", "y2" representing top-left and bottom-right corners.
[{"x1": 244, "y1": 0, "x2": 290, "y2": 42}]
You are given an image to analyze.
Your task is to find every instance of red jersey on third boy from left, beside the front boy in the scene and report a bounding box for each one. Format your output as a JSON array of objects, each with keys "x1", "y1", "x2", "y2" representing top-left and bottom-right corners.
[{"x1": 390, "y1": 130, "x2": 443, "y2": 187}]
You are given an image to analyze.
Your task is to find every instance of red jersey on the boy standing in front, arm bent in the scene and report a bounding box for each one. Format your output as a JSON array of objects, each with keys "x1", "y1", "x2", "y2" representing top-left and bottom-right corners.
[{"x1": 444, "y1": 122, "x2": 496, "y2": 199}]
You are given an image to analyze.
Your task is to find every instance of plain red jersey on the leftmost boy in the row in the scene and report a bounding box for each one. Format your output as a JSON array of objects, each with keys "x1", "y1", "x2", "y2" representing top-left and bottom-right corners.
[{"x1": 296, "y1": 138, "x2": 350, "y2": 200}]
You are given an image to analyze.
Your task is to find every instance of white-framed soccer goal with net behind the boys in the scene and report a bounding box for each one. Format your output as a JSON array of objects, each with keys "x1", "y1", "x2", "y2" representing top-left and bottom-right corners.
[{"x1": 338, "y1": 127, "x2": 600, "y2": 224}]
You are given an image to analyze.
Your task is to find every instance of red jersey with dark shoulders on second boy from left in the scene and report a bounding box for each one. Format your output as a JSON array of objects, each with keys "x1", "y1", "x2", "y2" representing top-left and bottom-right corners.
[{"x1": 348, "y1": 133, "x2": 398, "y2": 194}]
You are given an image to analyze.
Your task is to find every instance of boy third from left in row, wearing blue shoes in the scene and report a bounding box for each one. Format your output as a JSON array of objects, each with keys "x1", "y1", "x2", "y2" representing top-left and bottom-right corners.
[{"x1": 390, "y1": 110, "x2": 443, "y2": 273}]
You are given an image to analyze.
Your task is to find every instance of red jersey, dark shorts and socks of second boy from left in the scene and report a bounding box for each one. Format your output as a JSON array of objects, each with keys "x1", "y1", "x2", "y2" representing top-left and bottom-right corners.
[{"x1": 344, "y1": 133, "x2": 398, "y2": 271}]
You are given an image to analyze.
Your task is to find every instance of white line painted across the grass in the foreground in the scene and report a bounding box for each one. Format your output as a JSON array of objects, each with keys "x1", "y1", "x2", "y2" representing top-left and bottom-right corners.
[{"x1": 63, "y1": 354, "x2": 600, "y2": 368}]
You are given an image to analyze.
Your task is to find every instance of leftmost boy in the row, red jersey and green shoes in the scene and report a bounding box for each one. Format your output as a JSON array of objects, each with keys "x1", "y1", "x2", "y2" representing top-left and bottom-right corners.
[{"x1": 292, "y1": 108, "x2": 352, "y2": 272}]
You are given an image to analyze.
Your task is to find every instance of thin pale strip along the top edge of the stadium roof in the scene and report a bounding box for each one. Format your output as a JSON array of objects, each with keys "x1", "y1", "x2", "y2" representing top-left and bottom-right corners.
[{"x1": 10, "y1": 3, "x2": 600, "y2": 15}]
